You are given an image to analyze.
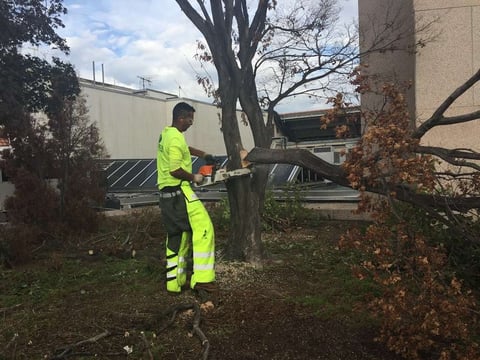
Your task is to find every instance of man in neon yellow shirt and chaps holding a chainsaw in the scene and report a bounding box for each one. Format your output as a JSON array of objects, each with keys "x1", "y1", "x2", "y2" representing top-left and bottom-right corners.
[{"x1": 157, "y1": 102, "x2": 215, "y2": 293}]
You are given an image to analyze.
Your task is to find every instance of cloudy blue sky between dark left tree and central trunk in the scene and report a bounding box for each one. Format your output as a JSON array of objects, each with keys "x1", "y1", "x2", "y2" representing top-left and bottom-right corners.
[{"x1": 48, "y1": 0, "x2": 358, "y2": 111}]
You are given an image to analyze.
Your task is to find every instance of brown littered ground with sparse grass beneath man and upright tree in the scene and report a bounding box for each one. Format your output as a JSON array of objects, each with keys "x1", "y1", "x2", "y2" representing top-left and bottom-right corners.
[{"x1": 0, "y1": 212, "x2": 404, "y2": 360}]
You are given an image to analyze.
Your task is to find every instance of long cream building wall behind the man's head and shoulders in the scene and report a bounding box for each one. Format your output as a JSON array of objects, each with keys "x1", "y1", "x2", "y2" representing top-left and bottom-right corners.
[{"x1": 80, "y1": 81, "x2": 254, "y2": 159}]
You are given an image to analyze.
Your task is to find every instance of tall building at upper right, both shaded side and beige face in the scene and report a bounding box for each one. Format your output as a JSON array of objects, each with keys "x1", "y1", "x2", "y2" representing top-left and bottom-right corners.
[{"x1": 358, "y1": 0, "x2": 480, "y2": 151}]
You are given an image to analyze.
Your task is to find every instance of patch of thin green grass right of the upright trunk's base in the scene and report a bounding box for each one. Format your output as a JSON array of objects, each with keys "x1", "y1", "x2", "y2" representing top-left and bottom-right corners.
[{"x1": 260, "y1": 224, "x2": 380, "y2": 325}]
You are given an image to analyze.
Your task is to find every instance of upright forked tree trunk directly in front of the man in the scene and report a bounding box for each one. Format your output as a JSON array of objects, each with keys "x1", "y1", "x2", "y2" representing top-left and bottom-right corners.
[{"x1": 176, "y1": 0, "x2": 271, "y2": 263}]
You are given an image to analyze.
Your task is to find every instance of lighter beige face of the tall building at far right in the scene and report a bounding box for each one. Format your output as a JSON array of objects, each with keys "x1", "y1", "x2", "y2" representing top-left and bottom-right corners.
[{"x1": 415, "y1": 0, "x2": 480, "y2": 151}]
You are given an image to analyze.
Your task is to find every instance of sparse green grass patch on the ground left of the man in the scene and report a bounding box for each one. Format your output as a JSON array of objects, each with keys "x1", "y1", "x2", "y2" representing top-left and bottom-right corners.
[{"x1": 0, "y1": 259, "x2": 167, "y2": 358}]
